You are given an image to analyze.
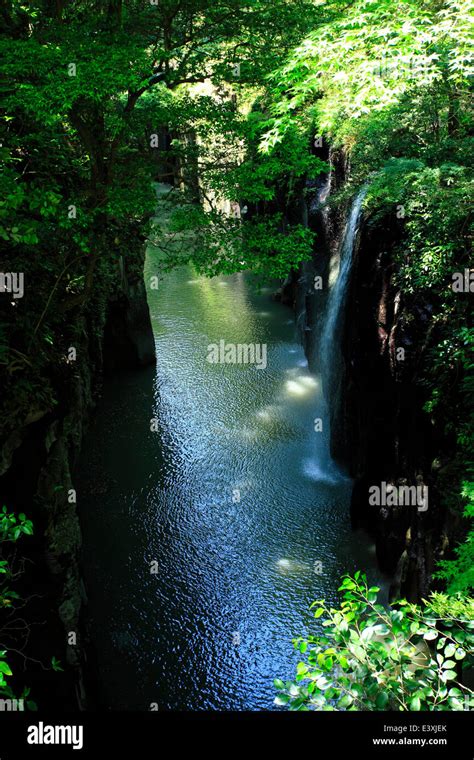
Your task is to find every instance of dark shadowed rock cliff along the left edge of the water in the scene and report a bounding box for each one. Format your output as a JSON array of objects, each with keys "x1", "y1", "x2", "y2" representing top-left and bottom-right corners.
[{"x1": 0, "y1": 244, "x2": 155, "y2": 709}]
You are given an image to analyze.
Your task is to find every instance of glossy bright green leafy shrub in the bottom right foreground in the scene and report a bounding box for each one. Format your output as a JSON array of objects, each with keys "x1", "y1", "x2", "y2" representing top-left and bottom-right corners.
[{"x1": 275, "y1": 572, "x2": 474, "y2": 711}]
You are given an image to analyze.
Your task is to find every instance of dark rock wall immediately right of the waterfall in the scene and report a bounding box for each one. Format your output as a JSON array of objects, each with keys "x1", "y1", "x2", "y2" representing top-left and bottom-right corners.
[{"x1": 331, "y1": 211, "x2": 451, "y2": 601}]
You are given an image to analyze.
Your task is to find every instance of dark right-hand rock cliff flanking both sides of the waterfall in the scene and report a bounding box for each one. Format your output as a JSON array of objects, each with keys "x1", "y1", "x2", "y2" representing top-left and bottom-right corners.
[{"x1": 279, "y1": 151, "x2": 456, "y2": 601}]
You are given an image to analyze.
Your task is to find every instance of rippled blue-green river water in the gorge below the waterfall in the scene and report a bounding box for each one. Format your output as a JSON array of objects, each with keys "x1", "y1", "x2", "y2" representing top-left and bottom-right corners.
[{"x1": 78, "y1": 212, "x2": 383, "y2": 710}]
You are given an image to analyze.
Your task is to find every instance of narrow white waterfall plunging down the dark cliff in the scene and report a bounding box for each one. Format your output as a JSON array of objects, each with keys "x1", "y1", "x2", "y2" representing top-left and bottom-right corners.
[{"x1": 319, "y1": 186, "x2": 367, "y2": 403}]
